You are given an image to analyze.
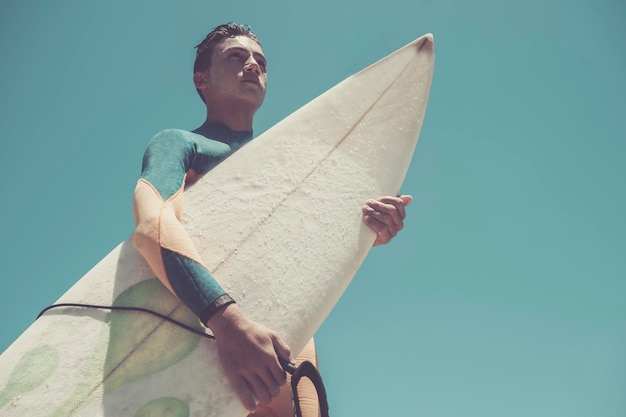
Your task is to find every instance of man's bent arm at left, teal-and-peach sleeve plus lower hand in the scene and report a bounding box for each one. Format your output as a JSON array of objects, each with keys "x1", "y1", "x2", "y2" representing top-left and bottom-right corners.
[{"x1": 133, "y1": 130, "x2": 290, "y2": 409}]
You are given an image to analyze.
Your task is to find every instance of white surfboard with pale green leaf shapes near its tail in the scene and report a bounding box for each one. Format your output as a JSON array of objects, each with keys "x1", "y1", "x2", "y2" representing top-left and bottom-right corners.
[{"x1": 0, "y1": 34, "x2": 434, "y2": 417}]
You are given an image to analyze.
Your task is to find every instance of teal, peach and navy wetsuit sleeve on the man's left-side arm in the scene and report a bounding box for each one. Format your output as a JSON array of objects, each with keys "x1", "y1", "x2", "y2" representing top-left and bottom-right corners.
[{"x1": 133, "y1": 130, "x2": 234, "y2": 324}]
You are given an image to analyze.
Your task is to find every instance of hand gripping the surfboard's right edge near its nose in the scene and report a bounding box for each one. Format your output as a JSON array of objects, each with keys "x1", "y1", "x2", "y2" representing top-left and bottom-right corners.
[{"x1": 362, "y1": 195, "x2": 413, "y2": 246}]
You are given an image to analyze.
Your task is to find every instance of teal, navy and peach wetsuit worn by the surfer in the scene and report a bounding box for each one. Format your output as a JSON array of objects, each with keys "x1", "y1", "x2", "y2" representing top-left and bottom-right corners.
[{"x1": 133, "y1": 122, "x2": 319, "y2": 417}]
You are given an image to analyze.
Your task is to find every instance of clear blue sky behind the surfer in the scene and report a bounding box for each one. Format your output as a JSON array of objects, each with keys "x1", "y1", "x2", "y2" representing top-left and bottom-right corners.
[{"x1": 0, "y1": 0, "x2": 626, "y2": 417}]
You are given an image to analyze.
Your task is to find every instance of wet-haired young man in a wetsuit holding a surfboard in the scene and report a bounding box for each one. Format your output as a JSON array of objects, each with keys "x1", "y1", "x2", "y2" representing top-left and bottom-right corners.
[{"x1": 133, "y1": 23, "x2": 412, "y2": 417}]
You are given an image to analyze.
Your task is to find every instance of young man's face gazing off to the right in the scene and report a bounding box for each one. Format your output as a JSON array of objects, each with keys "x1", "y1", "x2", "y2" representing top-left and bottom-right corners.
[{"x1": 203, "y1": 36, "x2": 267, "y2": 112}]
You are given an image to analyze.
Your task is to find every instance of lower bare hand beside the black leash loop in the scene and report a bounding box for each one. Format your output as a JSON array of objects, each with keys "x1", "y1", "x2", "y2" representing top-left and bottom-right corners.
[{"x1": 207, "y1": 304, "x2": 294, "y2": 411}]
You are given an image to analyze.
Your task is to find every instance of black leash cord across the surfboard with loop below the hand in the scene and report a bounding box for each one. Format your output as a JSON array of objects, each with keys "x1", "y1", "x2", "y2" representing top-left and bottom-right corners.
[{"x1": 37, "y1": 303, "x2": 329, "y2": 417}]
